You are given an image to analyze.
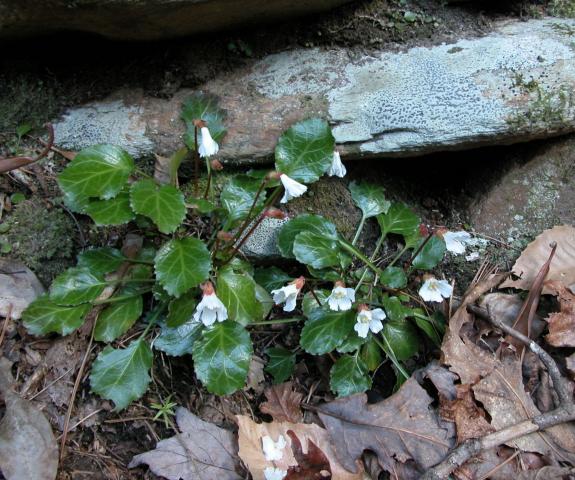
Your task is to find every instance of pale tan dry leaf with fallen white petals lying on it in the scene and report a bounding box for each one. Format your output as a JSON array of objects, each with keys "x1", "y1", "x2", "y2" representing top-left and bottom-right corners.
[{"x1": 236, "y1": 415, "x2": 363, "y2": 480}]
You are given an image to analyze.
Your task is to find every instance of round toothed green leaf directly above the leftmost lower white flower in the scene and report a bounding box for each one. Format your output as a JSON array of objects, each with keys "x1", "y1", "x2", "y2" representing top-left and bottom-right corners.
[{"x1": 154, "y1": 237, "x2": 212, "y2": 297}]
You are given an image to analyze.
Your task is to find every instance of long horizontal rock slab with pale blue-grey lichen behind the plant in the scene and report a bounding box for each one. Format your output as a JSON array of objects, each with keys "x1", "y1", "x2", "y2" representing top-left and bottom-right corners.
[{"x1": 53, "y1": 19, "x2": 575, "y2": 164}]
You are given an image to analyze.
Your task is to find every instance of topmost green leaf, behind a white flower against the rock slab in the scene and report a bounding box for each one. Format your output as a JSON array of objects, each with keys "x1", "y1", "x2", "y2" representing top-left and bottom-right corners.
[{"x1": 181, "y1": 92, "x2": 226, "y2": 151}]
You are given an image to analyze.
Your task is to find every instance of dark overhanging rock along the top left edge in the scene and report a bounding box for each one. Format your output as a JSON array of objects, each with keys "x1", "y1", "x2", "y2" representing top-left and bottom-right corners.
[{"x1": 0, "y1": 0, "x2": 349, "y2": 40}]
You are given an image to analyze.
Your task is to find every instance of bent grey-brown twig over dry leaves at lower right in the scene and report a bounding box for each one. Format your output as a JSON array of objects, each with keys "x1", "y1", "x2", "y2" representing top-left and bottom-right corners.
[{"x1": 421, "y1": 305, "x2": 575, "y2": 480}]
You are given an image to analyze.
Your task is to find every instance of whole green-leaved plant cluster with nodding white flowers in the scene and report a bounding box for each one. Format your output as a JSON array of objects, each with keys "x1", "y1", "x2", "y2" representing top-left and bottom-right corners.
[{"x1": 23, "y1": 94, "x2": 452, "y2": 410}]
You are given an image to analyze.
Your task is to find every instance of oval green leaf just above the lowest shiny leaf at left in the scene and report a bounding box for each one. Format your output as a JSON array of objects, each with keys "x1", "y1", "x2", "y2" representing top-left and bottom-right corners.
[{"x1": 94, "y1": 291, "x2": 144, "y2": 343}]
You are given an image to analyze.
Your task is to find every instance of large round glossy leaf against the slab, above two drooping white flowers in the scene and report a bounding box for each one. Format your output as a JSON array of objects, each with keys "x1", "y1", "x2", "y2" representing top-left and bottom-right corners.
[{"x1": 275, "y1": 118, "x2": 335, "y2": 183}]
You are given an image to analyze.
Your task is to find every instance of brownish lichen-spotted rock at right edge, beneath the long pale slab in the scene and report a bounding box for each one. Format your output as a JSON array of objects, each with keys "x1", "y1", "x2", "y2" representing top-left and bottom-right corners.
[{"x1": 470, "y1": 136, "x2": 575, "y2": 250}]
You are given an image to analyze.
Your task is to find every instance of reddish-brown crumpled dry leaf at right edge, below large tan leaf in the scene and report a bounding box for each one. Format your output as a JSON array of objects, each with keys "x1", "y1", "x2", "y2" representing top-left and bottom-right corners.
[{"x1": 545, "y1": 281, "x2": 575, "y2": 347}]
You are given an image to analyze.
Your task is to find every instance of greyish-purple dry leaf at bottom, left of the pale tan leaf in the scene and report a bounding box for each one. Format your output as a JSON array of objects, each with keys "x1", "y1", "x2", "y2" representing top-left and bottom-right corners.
[{"x1": 128, "y1": 407, "x2": 242, "y2": 480}]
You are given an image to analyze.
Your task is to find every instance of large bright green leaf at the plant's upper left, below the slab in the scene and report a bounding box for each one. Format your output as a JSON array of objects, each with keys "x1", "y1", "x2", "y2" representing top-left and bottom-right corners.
[{"x1": 58, "y1": 145, "x2": 135, "y2": 200}]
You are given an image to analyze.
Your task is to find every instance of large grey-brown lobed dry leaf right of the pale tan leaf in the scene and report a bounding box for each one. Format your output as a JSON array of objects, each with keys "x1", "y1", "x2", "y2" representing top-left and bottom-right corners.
[{"x1": 319, "y1": 378, "x2": 455, "y2": 477}]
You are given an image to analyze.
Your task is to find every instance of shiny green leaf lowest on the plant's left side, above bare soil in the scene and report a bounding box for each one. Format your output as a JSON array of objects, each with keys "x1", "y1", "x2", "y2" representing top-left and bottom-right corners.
[{"x1": 90, "y1": 339, "x2": 153, "y2": 412}]
